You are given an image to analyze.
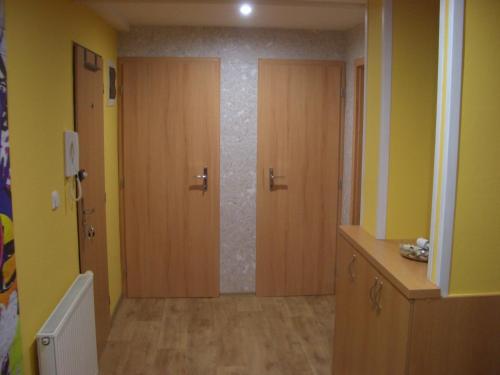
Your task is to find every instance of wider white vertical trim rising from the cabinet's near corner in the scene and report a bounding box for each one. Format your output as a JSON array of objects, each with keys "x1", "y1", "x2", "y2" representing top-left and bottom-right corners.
[{"x1": 436, "y1": 0, "x2": 465, "y2": 296}]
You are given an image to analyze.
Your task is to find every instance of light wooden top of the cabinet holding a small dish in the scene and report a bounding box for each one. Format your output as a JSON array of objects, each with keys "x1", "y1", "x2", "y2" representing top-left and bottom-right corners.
[{"x1": 340, "y1": 226, "x2": 441, "y2": 299}]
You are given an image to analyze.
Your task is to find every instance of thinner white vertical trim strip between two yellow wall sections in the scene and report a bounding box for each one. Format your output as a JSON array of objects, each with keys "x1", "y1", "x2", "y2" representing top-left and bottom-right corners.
[{"x1": 376, "y1": 0, "x2": 392, "y2": 239}]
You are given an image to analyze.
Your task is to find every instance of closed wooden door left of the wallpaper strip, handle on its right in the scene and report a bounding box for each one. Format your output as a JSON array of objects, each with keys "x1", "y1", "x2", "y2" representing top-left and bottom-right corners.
[{"x1": 120, "y1": 58, "x2": 220, "y2": 297}]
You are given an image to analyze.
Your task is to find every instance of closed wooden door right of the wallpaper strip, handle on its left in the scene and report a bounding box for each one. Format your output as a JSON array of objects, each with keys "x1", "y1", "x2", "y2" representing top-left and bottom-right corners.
[{"x1": 256, "y1": 60, "x2": 343, "y2": 296}]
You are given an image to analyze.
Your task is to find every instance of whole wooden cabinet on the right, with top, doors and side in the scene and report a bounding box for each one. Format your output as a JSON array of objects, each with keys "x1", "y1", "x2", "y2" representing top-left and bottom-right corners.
[{"x1": 332, "y1": 226, "x2": 500, "y2": 375}]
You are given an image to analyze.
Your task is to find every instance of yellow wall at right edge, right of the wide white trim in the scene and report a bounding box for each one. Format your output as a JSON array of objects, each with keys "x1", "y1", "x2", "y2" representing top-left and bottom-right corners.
[{"x1": 450, "y1": 0, "x2": 500, "y2": 295}]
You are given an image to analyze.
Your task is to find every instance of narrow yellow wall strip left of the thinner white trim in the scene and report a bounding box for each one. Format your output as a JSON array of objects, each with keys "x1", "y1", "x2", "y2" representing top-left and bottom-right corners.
[{"x1": 361, "y1": 0, "x2": 382, "y2": 235}]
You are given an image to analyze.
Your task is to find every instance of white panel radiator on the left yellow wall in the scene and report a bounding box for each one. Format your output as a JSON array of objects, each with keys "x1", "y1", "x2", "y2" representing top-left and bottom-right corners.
[{"x1": 37, "y1": 272, "x2": 98, "y2": 375}]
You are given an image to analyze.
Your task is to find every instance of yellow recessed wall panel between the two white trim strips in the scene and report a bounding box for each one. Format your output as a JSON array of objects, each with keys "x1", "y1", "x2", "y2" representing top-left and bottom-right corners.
[{"x1": 386, "y1": 0, "x2": 439, "y2": 238}]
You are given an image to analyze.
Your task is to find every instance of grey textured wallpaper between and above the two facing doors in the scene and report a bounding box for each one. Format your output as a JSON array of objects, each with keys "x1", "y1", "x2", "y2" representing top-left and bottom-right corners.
[{"x1": 119, "y1": 27, "x2": 366, "y2": 293}]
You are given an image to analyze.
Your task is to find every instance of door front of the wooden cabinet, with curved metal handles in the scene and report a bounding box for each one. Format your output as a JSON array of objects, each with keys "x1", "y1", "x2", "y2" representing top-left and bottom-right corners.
[{"x1": 333, "y1": 237, "x2": 410, "y2": 375}]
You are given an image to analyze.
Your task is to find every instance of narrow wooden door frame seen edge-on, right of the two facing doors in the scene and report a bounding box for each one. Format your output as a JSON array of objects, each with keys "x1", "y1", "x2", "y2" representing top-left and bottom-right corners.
[{"x1": 351, "y1": 59, "x2": 365, "y2": 225}]
